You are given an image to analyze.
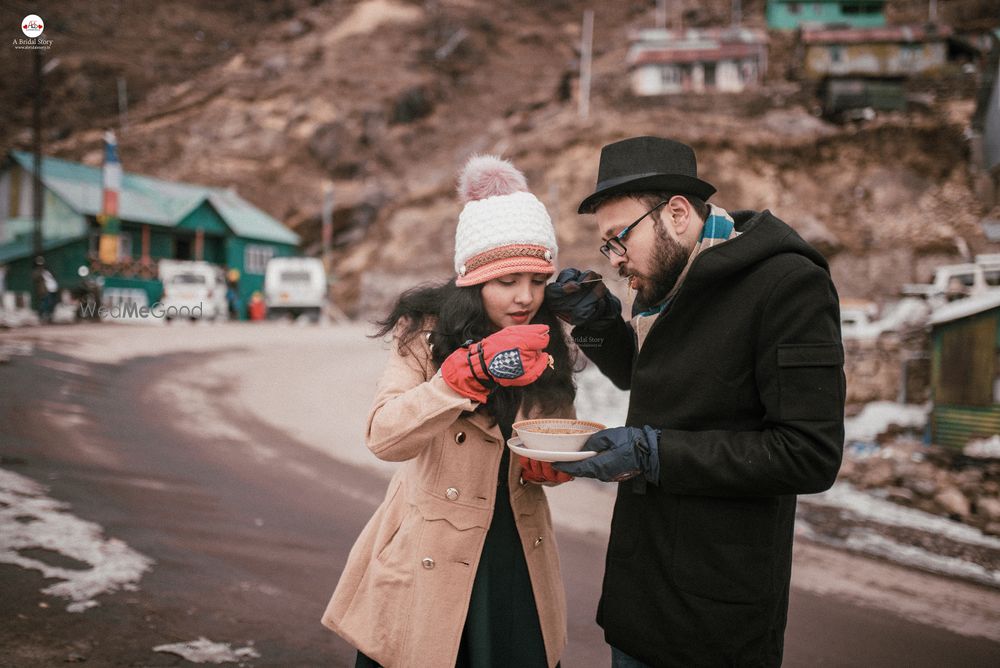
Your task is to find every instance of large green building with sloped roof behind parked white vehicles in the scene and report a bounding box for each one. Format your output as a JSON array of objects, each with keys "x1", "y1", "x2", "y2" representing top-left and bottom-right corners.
[{"x1": 0, "y1": 151, "x2": 299, "y2": 318}]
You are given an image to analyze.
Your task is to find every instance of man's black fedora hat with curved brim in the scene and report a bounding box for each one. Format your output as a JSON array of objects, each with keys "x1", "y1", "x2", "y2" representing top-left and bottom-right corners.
[{"x1": 578, "y1": 137, "x2": 715, "y2": 213}]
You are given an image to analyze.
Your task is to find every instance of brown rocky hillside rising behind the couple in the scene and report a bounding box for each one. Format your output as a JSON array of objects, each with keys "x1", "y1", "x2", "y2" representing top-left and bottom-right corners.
[{"x1": 0, "y1": 0, "x2": 991, "y2": 312}]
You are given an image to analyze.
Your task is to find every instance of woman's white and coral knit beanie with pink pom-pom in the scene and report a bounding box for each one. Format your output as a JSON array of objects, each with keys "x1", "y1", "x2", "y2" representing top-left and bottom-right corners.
[{"x1": 455, "y1": 155, "x2": 559, "y2": 286}]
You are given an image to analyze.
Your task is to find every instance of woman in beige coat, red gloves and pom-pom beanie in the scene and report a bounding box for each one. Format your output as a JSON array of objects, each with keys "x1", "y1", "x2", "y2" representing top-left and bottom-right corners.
[{"x1": 323, "y1": 156, "x2": 575, "y2": 668}]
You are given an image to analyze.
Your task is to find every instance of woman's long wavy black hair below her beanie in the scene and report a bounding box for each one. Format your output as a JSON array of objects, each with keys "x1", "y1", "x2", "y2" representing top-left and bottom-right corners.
[{"x1": 373, "y1": 279, "x2": 576, "y2": 425}]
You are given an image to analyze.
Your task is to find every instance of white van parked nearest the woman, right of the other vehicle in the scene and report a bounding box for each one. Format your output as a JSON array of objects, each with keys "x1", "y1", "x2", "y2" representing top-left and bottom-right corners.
[{"x1": 264, "y1": 257, "x2": 327, "y2": 322}]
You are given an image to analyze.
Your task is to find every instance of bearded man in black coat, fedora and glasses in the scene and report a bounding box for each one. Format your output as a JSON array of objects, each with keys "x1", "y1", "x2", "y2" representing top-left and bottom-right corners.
[{"x1": 546, "y1": 137, "x2": 845, "y2": 667}]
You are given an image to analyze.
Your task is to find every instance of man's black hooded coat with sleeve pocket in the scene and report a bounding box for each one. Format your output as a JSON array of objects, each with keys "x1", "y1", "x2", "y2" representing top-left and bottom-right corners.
[{"x1": 573, "y1": 211, "x2": 845, "y2": 668}]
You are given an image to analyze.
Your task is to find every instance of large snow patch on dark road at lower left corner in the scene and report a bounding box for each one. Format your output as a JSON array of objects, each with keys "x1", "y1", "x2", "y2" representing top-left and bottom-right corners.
[{"x1": 0, "y1": 469, "x2": 154, "y2": 612}]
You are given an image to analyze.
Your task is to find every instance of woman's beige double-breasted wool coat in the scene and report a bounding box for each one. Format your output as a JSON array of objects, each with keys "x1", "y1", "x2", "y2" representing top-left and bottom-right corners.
[{"x1": 322, "y1": 320, "x2": 572, "y2": 668}]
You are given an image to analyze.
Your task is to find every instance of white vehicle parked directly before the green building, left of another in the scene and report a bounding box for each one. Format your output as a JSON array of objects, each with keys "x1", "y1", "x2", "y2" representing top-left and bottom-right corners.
[{"x1": 159, "y1": 260, "x2": 229, "y2": 322}]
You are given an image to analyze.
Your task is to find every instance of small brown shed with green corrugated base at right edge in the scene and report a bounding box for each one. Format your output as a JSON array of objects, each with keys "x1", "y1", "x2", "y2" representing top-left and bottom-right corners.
[{"x1": 930, "y1": 292, "x2": 1000, "y2": 447}]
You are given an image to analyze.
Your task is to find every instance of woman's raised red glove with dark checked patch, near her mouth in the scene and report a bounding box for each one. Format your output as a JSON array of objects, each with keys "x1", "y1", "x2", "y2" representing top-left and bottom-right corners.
[{"x1": 441, "y1": 325, "x2": 549, "y2": 404}]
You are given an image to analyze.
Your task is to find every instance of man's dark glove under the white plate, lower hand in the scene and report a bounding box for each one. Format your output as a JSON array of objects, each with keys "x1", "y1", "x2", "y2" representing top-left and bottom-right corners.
[{"x1": 552, "y1": 427, "x2": 660, "y2": 484}]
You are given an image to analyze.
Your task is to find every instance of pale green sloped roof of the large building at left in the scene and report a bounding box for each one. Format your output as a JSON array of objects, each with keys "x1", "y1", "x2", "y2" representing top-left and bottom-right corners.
[{"x1": 10, "y1": 151, "x2": 299, "y2": 245}]
